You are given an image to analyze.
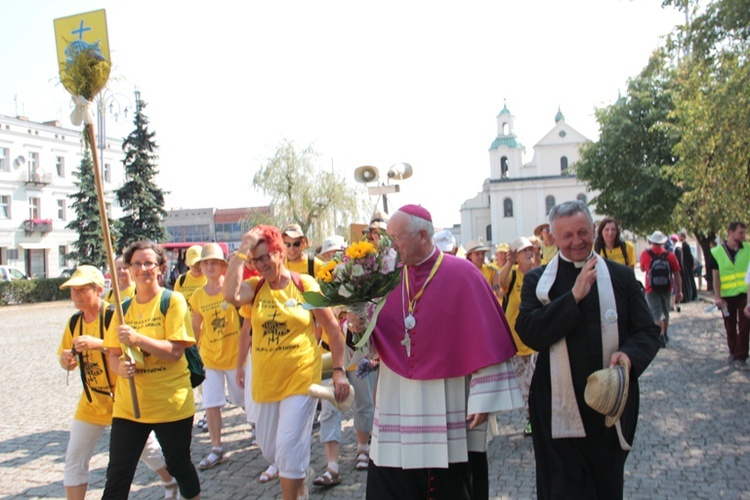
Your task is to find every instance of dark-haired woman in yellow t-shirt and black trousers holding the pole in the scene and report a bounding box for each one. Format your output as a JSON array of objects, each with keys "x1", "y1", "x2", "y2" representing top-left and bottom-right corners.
[{"x1": 103, "y1": 240, "x2": 201, "y2": 498}]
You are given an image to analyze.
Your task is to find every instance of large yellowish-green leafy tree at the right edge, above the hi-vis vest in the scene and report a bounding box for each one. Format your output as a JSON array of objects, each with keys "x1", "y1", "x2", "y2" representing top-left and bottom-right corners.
[{"x1": 668, "y1": 0, "x2": 750, "y2": 274}]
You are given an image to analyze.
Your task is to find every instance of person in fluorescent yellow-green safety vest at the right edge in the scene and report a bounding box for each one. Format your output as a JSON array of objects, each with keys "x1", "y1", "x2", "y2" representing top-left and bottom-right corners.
[{"x1": 710, "y1": 221, "x2": 750, "y2": 370}]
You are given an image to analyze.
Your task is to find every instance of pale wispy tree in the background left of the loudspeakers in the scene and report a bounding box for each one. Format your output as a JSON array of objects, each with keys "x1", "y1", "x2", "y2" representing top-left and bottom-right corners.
[{"x1": 252, "y1": 139, "x2": 365, "y2": 242}]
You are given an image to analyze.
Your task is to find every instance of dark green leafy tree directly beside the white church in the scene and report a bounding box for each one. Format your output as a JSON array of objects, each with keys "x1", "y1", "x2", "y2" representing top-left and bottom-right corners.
[{"x1": 575, "y1": 51, "x2": 682, "y2": 235}]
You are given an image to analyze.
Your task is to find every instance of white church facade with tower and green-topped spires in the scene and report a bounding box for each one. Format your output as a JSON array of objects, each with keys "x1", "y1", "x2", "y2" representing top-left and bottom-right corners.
[{"x1": 461, "y1": 106, "x2": 596, "y2": 248}]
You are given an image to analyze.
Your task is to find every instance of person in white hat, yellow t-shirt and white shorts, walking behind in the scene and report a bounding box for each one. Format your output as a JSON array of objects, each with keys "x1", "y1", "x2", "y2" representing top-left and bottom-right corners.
[{"x1": 189, "y1": 243, "x2": 244, "y2": 470}]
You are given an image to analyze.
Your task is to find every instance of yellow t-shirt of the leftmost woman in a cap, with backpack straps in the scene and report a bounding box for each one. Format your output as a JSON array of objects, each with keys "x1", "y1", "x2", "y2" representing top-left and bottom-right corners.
[{"x1": 57, "y1": 303, "x2": 116, "y2": 425}]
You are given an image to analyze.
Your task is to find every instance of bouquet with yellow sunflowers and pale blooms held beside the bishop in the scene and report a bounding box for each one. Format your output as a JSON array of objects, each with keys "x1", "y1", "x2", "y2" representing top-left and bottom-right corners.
[{"x1": 302, "y1": 235, "x2": 401, "y2": 348}]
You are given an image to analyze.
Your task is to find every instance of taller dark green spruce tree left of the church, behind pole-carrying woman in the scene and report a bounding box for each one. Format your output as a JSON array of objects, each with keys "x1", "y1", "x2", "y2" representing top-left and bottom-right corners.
[{"x1": 116, "y1": 92, "x2": 167, "y2": 252}]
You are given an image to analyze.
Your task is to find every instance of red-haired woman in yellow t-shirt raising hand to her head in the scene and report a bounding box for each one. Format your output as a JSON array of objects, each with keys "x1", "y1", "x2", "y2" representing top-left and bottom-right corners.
[{"x1": 224, "y1": 226, "x2": 349, "y2": 500}]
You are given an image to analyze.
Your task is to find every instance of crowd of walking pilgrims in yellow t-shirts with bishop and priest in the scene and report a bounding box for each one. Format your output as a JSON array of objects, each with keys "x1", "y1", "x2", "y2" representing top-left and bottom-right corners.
[{"x1": 58, "y1": 201, "x2": 750, "y2": 500}]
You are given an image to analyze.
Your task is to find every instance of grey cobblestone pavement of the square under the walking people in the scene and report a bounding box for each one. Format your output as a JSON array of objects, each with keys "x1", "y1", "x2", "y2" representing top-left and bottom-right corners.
[{"x1": 0, "y1": 301, "x2": 750, "y2": 499}]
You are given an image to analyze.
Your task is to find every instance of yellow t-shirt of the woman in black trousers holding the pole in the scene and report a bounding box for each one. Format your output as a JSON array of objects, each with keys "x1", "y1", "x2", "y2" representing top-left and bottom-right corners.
[{"x1": 104, "y1": 290, "x2": 195, "y2": 424}]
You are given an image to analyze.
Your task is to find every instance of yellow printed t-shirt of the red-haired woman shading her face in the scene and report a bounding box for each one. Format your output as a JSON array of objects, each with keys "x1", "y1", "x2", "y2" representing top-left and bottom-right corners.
[{"x1": 242, "y1": 274, "x2": 321, "y2": 403}]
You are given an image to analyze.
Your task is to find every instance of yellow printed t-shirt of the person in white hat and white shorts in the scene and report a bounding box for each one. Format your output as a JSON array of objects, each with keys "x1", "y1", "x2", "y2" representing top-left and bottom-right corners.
[{"x1": 189, "y1": 287, "x2": 240, "y2": 370}]
